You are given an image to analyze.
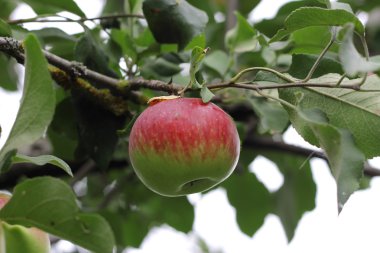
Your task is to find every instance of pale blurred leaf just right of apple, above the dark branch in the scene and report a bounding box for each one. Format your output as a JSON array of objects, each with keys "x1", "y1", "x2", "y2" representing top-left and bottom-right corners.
[{"x1": 249, "y1": 97, "x2": 289, "y2": 134}]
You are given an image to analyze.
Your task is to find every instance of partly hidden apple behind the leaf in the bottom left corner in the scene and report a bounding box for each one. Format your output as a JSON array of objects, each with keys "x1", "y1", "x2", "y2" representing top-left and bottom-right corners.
[{"x1": 0, "y1": 192, "x2": 50, "y2": 253}]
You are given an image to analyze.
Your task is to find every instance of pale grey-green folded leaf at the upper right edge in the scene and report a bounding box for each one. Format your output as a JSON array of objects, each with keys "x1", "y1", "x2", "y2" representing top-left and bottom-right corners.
[{"x1": 339, "y1": 24, "x2": 380, "y2": 77}]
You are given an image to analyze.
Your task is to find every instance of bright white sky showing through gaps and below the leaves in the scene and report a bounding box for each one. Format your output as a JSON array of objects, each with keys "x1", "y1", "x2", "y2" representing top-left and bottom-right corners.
[{"x1": 0, "y1": 0, "x2": 380, "y2": 253}]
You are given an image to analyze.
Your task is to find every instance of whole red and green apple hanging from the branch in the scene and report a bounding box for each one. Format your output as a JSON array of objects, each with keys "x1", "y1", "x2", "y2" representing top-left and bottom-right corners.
[{"x1": 129, "y1": 97, "x2": 240, "y2": 197}]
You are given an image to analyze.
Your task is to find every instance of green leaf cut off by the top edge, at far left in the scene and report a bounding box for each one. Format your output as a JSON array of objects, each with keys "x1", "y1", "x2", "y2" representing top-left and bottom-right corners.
[{"x1": 24, "y1": 0, "x2": 85, "y2": 17}]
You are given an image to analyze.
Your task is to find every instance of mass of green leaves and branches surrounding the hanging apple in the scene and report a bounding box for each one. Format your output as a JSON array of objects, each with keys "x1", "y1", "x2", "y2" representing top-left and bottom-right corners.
[{"x1": 0, "y1": 0, "x2": 380, "y2": 253}]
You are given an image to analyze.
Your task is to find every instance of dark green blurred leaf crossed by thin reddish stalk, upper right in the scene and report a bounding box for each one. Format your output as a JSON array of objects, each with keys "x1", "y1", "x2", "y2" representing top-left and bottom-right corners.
[{"x1": 288, "y1": 54, "x2": 344, "y2": 79}]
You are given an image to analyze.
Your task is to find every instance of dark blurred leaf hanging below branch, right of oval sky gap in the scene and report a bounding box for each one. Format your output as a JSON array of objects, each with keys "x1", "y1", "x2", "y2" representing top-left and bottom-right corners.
[{"x1": 263, "y1": 152, "x2": 316, "y2": 241}]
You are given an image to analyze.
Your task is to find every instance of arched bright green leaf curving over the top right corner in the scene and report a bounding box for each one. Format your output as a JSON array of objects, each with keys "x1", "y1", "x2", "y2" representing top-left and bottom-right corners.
[{"x1": 270, "y1": 7, "x2": 364, "y2": 42}]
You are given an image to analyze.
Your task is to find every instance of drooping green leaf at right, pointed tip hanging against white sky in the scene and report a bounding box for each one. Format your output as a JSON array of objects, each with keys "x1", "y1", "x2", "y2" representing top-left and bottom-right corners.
[{"x1": 278, "y1": 104, "x2": 365, "y2": 212}]
